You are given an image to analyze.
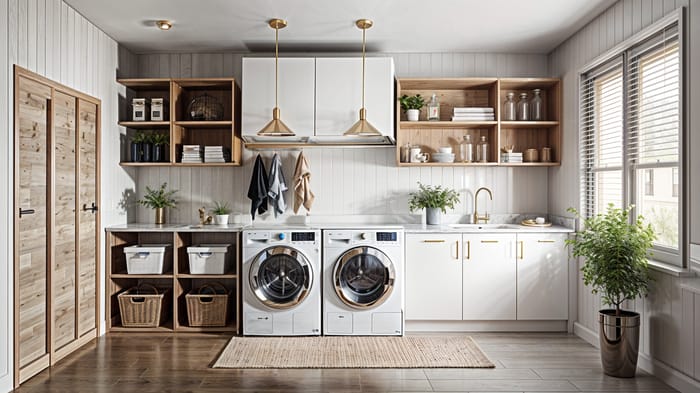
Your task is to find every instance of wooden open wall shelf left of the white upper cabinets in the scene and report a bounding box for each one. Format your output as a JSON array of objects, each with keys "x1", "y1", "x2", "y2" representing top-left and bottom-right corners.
[{"x1": 117, "y1": 78, "x2": 241, "y2": 167}]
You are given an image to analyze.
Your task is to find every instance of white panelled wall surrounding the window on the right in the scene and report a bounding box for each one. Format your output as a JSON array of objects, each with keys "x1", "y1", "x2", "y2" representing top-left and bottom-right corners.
[{"x1": 549, "y1": 0, "x2": 700, "y2": 391}]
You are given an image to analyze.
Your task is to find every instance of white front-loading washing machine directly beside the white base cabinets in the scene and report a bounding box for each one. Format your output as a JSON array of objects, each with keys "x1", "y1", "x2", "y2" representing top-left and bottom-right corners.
[{"x1": 323, "y1": 227, "x2": 404, "y2": 336}]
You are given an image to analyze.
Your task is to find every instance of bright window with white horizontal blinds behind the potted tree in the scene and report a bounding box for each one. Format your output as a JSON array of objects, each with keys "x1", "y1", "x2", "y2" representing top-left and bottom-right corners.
[{"x1": 580, "y1": 20, "x2": 683, "y2": 265}]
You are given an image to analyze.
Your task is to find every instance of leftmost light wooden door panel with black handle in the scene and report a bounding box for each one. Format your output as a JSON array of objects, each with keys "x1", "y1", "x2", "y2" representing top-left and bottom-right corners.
[{"x1": 14, "y1": 72, "x2": 52, "y2": 383}]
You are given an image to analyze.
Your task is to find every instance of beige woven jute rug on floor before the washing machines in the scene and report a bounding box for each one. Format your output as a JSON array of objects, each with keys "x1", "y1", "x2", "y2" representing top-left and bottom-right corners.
[{"x1": 213, "y1": 336, "x2": 495, "y2": 368}]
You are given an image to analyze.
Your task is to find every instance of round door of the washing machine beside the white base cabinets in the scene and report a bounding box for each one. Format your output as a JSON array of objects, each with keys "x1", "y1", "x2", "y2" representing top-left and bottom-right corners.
[{"x1": 333, "y1": 246, "x2": 396, "y2": 309}]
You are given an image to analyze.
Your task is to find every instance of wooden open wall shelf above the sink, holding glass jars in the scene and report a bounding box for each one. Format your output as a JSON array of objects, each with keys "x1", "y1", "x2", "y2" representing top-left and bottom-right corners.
[{"x1": 396, "y1": 78, "x2": 561, "y2": 167}]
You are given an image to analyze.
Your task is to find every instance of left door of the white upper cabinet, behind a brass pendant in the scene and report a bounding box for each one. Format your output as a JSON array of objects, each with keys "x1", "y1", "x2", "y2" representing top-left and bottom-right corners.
[{"x1": 241, "y1": 57, "x2": 315, "y2": 136}]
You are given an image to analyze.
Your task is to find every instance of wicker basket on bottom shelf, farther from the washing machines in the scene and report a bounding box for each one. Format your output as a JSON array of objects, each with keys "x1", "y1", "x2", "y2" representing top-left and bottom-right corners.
[{"x1": 117, "y1": 283, "x2": 170, "y2": 328}]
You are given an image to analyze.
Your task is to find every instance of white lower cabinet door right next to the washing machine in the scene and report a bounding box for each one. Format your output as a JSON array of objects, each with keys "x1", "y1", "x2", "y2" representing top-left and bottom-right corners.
[{"x1": 406, "y1": 233, "x2": 462, "y2": 320}]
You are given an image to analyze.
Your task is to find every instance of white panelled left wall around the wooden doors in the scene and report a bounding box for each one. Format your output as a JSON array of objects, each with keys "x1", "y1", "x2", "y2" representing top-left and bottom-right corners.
[{"x1": 0, "y1": 0, "x2": 138, "y2": 392}]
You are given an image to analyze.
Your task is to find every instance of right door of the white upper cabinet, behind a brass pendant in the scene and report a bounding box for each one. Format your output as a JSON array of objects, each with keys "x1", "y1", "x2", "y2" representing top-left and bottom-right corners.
[{"x1": 316, "y1": 57, "x2": 396, "y2": 137}]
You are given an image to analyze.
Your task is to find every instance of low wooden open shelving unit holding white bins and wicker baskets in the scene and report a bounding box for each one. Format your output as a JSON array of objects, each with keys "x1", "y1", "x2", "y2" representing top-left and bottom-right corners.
[{"x1": 105, "y1": 230, "x2": 240, "y2": 334}]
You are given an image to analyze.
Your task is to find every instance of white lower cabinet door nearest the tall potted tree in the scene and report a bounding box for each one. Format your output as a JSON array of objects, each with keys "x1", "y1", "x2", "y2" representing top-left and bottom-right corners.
[{"x1": 517, "y1": 233, "x2": 569, "y2": 320}]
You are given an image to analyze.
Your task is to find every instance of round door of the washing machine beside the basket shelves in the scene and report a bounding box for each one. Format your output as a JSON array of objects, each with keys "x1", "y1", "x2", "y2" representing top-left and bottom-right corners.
[{"x1": 248, "y1": 246, "x2": 313, "y2": 310}]
